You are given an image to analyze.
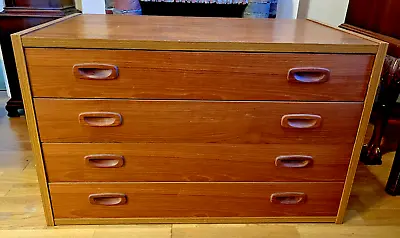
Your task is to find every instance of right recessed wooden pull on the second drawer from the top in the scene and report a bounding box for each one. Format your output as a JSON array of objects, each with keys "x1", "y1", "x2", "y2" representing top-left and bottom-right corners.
[{"x1": 281, "y1": 114, "x2": 322, "y2": 129}]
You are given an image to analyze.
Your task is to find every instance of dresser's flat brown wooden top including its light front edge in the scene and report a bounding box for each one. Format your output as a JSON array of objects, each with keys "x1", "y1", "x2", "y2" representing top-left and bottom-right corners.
[{"x1": 22, "y1": 14, "x2": 378, "y2": 53}]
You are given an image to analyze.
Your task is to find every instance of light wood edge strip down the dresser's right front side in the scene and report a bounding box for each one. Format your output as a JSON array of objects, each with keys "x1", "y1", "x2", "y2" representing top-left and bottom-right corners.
[{"x1": 336, "y1": 42, "x2": 388, "y2": 224}]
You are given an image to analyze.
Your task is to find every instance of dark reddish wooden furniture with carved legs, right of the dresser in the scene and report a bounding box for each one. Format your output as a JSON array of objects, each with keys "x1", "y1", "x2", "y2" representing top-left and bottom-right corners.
[{"x1": 341, "y1": 0, "x2": 400, "y2": 195}]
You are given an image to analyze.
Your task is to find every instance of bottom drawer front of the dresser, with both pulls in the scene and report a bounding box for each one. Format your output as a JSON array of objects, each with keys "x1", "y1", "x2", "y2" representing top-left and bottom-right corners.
[{"x1": 50, "y1": 183, "x2": 343, "y2": 218}]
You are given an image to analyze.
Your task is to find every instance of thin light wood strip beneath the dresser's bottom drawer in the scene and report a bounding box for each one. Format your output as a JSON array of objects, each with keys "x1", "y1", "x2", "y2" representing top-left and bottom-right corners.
[{"x1": 55, "y1": 216, "x2": 336, "y2": 225}]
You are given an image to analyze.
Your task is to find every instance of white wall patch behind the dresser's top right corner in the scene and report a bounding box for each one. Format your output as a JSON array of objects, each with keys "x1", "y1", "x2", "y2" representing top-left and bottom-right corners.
[{"x1": 298, "y1": 0, "x2": 349, "y2": 26}]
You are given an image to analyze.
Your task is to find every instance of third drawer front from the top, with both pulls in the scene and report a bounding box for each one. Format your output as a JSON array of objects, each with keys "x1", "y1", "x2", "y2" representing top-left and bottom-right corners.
[{"x1": 42, "y1": 143, "x2": 352, "y2": 182}]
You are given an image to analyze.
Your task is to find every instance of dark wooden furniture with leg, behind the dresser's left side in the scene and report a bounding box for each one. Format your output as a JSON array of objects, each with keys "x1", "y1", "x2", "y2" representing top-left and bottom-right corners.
[{"x1": 0, "y1": 0, "x2": 78, "y2": 117}]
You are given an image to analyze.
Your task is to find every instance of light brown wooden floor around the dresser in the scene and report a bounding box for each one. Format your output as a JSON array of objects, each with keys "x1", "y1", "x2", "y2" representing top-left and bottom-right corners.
[{"x1": 0, "y1": 92, "x2": 400, "y2": 238}]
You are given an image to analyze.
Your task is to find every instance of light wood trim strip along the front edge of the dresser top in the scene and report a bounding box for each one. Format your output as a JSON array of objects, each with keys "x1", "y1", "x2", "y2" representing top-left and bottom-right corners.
[{"x1": 22, "y1": 37, "x2": 377, "y2": 54}]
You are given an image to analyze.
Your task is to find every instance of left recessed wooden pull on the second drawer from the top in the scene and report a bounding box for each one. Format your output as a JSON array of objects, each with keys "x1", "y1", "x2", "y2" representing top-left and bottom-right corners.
[{"x1": 79, "y1": 112, "x2": 122, "y2": 127}]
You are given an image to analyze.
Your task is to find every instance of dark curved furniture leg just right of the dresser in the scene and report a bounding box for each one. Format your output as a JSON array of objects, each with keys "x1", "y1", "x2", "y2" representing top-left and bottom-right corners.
[{"x1": 360, "y1": 56, "x2": 400, "y2": 165}]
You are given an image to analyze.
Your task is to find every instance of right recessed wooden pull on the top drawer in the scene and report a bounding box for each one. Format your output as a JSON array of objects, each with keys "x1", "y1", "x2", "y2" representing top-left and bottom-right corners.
[{"x1": 288, "y1": 67, "x2": 331, "y2": 83}]
